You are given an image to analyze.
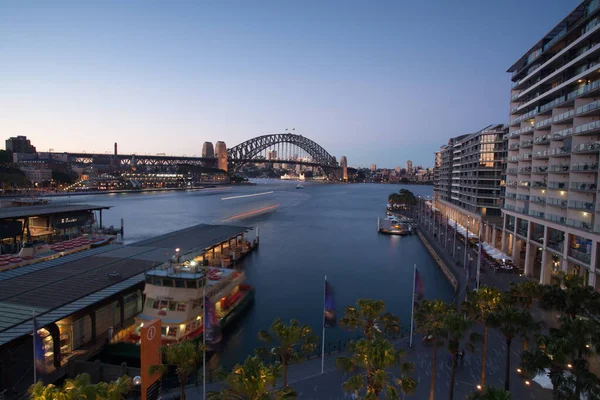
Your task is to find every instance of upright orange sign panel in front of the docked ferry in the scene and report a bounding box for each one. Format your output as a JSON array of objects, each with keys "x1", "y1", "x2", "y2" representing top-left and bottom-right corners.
[{"x1": 140, "y1": 319, "x2": 162, "y2": 400}]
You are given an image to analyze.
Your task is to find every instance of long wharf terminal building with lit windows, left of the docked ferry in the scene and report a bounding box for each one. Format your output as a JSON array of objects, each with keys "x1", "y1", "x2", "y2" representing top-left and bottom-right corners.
[{"x1": 0, "y1": 224, "x2": 256, "y2": 394}]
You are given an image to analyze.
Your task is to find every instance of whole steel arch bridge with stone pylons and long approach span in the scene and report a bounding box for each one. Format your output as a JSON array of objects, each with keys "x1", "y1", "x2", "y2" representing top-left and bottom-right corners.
[{"x1": 61, "y1": 133, "x2": 348, "y2": 180}]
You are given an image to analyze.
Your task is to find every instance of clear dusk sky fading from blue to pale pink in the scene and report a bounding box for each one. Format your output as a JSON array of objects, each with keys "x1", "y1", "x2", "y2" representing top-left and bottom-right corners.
[{"x1": 0, "y1": 0, "x2": 580, "y2": 168}]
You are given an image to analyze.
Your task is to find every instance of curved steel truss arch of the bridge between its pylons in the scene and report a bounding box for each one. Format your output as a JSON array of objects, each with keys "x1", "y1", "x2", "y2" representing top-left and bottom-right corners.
[{"x1": 227, "y1": 133, "x2": 339, "y2": 171}]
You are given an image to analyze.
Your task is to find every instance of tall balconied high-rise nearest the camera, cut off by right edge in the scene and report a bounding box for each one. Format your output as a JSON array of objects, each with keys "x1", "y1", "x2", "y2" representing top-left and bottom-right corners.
[{"x1": 502, "y1": 0, "x2": 600, "y2": 290}]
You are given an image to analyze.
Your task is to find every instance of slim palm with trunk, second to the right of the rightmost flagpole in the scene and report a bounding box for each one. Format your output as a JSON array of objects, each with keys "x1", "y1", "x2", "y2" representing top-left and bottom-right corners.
[{"x1": 443, "y1": 307, "x2": 479, "y2": 400}]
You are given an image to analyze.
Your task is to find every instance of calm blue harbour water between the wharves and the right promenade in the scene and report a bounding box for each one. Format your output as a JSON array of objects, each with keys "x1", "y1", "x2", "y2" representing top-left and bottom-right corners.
[{"x1": 54, "y1": 181, "x2": 452, "y2": 366}]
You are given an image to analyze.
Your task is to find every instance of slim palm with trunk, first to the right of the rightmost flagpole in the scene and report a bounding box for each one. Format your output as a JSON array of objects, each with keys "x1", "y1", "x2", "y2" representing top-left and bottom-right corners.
[{"x1": 415, "y1": 300, "x2": 450, "y2": 400}]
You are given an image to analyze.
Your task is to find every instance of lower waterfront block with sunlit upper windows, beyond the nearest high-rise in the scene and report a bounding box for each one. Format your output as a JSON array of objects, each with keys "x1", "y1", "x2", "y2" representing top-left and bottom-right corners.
[{"x1": 433, "y1": 124, "x2": 507, "y2": 242}]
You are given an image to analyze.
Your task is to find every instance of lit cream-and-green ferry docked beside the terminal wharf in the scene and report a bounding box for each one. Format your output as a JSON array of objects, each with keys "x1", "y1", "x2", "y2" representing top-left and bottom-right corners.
[{"x1": 127, "y1": 260, "x2": 254, "y2": 345}]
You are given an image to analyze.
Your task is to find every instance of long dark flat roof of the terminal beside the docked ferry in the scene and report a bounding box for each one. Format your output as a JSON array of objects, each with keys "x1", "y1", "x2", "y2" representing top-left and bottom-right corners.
[{"x1": 0, "y1": 224, "x2": 251, "y2": 345}]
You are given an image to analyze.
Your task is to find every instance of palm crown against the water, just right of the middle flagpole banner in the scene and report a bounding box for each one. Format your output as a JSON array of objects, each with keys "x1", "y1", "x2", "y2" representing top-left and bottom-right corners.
[{"x1": 340, "y1": 299, "x2": 400, "y2": 340}]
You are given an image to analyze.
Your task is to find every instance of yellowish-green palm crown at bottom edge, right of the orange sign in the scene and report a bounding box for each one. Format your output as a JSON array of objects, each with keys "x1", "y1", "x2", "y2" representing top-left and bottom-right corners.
[{"x1": 207, "y1": 356, "x2": 297, "y2": 400}]
